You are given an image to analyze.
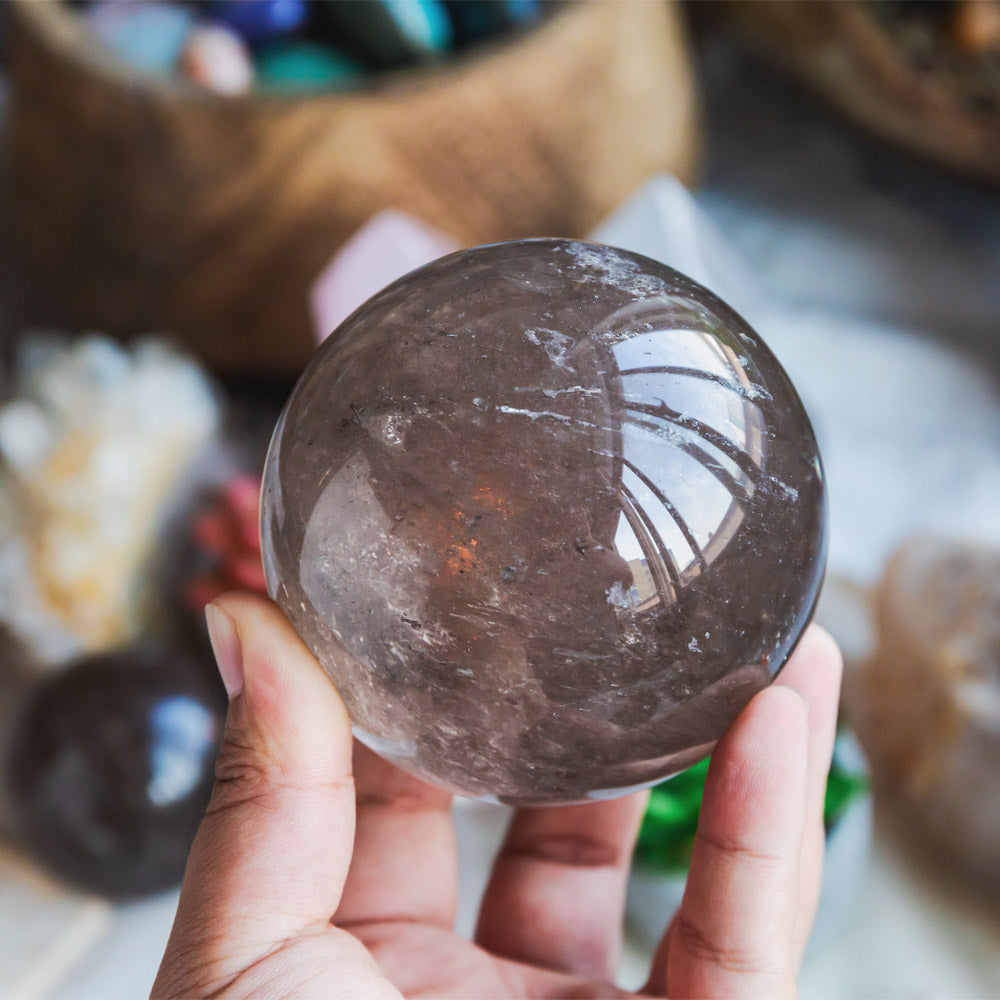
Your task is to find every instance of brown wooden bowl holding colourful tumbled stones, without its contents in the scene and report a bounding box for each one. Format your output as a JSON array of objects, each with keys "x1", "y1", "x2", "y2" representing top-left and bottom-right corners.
[{"x1": 3, "y1": 0, "x2": 699, "y2": 372}]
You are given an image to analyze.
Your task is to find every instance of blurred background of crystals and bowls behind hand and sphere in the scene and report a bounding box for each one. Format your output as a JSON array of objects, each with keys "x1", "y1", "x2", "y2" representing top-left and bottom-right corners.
[{"x1": 0, "y1": 0, "x2": 1000, "y2": 998}]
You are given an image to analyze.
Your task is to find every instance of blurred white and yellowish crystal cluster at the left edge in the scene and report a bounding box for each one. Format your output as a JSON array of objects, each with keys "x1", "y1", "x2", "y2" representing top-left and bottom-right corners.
[{"x1": 0, "y1": 333, "x2": 219, "y2": 663}]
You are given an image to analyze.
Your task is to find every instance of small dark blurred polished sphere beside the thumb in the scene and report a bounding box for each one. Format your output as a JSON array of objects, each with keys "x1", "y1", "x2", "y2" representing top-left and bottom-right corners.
[{"x1": 5, "y1": 647, "x2": 225, "y2": 898}]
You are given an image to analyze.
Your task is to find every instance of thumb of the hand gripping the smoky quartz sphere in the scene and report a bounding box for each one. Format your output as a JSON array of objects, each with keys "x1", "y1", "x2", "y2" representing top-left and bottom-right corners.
[{"x1": 154, "y1": 594, "x2": 354, "y2": 995}]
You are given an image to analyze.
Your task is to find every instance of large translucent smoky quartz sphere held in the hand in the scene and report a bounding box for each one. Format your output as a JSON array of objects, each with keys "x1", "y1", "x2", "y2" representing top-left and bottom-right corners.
[{"x1": 262, "y1": 240, "x2": 825, "y2": 804}]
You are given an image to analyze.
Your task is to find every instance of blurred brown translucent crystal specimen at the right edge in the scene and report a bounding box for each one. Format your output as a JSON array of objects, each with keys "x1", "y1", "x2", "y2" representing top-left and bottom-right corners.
[{"x1": 844, "y1": 538, "x2": 1000, "y2": 893}]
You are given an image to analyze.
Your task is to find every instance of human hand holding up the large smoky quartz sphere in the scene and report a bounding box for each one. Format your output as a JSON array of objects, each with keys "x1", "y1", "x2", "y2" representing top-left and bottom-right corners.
[{"x1": 153, "y1": 594, "x2": 840, "y2": 1000}]
